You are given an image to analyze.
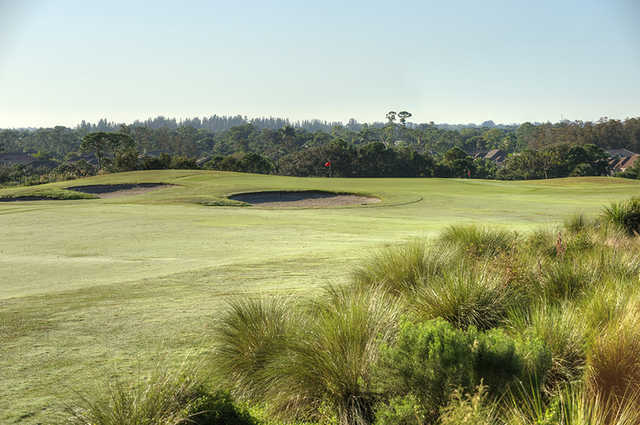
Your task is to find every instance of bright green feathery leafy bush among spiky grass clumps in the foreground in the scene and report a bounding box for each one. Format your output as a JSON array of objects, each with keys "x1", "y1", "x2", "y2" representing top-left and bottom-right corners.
[{"x1": 375, "y1": 319, "x2": 546, "y2": 421}]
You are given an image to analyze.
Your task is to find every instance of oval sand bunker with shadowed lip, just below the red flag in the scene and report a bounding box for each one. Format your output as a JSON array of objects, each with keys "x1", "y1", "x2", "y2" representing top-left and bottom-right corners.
[{"x1": 229, "y1": 190, "x2": 380, "y2": 208}]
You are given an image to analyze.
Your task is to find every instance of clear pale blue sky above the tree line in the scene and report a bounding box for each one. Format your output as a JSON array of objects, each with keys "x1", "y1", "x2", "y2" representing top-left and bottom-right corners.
[{"x1": 0, "y1": 0, "x2": 640, "y2": 128}]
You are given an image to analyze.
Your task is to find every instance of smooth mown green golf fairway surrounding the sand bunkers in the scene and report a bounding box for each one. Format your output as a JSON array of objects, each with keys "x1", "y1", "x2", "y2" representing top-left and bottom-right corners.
[{"x1": 0, "y1": 170, "x2": 640, "y2": 424}]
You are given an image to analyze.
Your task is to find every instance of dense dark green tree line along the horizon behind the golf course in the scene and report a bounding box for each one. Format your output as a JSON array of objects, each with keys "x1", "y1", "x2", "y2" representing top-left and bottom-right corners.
[{"x1": 0, "y1": 116, "x2": 640, "y2": 183}]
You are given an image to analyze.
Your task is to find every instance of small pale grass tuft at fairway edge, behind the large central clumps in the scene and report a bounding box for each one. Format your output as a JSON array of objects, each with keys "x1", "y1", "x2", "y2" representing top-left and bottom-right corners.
[{"x1": 438, "y1": 225, "x2": 518, "y2": 257}]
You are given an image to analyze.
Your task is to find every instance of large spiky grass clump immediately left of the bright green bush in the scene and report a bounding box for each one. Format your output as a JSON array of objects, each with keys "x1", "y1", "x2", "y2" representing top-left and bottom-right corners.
[{"x1": 268, "y1": 288, "x2": 399, "y2": 425}]
